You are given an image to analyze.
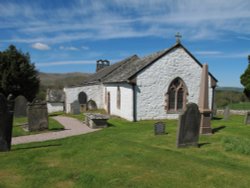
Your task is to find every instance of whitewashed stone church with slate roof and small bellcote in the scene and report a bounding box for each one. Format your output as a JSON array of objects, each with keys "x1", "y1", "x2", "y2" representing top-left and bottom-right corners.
[{"x1": 64, "y1": 41, "x2": 217, "y2": 121}]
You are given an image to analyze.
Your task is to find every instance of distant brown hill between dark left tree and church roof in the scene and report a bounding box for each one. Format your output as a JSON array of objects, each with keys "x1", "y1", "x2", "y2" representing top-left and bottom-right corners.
[{"x1": 39, "y1": 72, "x2": 91, "y2": 88}]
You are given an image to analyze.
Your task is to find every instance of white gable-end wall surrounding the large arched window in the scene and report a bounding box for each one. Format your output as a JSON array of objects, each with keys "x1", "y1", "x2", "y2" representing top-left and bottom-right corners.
[{"x1": 136, "y1": 48, "x2": 212, "y2": 120}]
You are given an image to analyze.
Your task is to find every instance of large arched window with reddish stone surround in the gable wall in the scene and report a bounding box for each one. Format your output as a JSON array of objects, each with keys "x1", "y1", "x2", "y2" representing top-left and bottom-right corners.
[{"x1": 165, "y1": 78, "x2": 188, "y2": 112}]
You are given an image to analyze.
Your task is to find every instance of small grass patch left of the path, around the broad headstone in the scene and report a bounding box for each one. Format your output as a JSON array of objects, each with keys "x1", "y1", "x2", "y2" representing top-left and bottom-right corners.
[{"x1": 12, "y1": 117, "x2": 64, "y2": 137}]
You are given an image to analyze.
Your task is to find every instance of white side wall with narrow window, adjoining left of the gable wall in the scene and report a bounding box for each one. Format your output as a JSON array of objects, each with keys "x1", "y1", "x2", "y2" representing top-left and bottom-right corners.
[{"x1": 106, "y1": 84, "x2": 133, "y2": 121}]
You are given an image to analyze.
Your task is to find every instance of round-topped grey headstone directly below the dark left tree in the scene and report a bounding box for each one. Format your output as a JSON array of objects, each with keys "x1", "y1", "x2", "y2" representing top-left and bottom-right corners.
[{"x1": 14, "y1": 95, "x2": 28, "y2": 117}]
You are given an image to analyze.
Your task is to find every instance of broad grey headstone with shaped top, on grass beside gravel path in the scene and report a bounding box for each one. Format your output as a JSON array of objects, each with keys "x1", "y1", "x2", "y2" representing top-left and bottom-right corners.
[{"x1": 28, "y1": 99, "x2": 49, "y2": 131}]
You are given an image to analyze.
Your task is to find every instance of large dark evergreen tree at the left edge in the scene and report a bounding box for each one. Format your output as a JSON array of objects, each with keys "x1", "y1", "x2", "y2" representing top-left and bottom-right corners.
[{"x1": 0, "y1": 45, "x2": 40, "y2": 101}]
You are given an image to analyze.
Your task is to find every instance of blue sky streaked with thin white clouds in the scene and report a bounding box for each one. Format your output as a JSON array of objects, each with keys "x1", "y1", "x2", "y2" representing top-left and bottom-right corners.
[{"x1": 0, "y1": 0, "x2": 250, "y2": 87}]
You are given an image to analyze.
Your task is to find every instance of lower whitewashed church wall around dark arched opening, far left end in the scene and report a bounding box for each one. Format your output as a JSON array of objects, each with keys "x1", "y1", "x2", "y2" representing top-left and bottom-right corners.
[{"x1": 64, "y1": 84, "x2": 103, "y2": 113}]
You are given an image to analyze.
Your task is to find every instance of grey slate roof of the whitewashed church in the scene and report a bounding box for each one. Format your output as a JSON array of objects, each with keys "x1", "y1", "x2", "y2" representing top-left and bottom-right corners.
[{"x1": 80, "y1": 43, "x2": 217, "y2": 84}]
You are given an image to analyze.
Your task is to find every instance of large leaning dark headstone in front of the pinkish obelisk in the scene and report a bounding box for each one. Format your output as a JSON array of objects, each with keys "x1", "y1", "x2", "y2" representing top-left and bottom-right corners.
[{"x1": 177, "y1": 103, "x2": 201, "y2": 147}]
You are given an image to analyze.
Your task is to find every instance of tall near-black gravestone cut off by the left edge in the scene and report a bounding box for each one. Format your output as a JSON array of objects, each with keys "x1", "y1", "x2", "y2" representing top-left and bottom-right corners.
[{"x1": 0, "y1": 93, "x2": 14, "y2": 151}]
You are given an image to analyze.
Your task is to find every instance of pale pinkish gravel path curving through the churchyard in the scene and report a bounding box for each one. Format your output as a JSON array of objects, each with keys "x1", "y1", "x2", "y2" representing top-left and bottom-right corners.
[{"x1": 12, "y1": 116, "x2": 100, "y2": 145}]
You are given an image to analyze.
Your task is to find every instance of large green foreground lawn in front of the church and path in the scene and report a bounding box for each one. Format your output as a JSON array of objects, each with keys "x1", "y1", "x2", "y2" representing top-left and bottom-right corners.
[{"x1": 0, "y1": 116, "x2": 250, "y2": 188}]
